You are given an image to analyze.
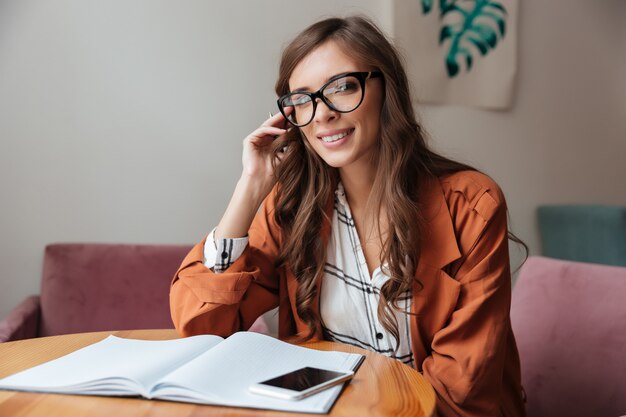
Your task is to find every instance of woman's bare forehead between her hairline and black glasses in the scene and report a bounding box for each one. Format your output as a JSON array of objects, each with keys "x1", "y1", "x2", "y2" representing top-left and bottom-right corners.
[{"x1": 289, "y1": 41, "x2": 365, "y2": 91}]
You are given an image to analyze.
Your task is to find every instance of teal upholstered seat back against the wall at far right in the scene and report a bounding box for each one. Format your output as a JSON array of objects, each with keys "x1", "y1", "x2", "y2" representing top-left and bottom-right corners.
[{"x1": 538, "y1": 205, "x2": 626, "y2": 266}]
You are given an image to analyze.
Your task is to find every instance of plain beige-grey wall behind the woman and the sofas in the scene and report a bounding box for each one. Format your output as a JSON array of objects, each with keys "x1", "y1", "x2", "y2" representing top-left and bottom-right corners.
[{"x1": 0, "y1": 0, "x2": 626, "y2": 317}]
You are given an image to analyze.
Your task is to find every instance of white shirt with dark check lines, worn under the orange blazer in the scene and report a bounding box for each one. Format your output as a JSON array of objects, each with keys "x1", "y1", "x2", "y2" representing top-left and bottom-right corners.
[{"x1": 204, "y1": 182, "x2": 415, "y2": 367}]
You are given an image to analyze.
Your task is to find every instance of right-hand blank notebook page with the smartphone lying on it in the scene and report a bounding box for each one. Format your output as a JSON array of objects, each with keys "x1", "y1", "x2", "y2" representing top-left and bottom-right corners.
[{"x1": 154, "y1": 332, "x2": 362, "y2": 413}]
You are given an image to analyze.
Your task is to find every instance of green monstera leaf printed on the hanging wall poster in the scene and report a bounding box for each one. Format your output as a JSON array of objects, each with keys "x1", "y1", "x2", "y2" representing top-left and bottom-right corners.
[{"x1": 421, "y1": 0, "x2": 507, "y2": 77}]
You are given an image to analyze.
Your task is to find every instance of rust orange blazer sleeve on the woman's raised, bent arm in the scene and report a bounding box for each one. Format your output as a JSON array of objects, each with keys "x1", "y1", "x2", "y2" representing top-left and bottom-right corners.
[{"x1": 170, "y1": 192, "x2": 279, "y2": 337}]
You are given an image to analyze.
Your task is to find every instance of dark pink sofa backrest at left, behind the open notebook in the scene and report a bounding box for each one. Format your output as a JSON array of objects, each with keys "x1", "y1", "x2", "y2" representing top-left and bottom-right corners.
[{"x1": 39, "y1": 244, "x2": 191, "y2": 336}]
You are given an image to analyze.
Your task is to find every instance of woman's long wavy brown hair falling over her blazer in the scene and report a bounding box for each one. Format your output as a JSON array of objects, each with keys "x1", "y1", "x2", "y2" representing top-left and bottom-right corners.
[{"x1": 274, "y1": 16, "x2": 520, "y2": 342}]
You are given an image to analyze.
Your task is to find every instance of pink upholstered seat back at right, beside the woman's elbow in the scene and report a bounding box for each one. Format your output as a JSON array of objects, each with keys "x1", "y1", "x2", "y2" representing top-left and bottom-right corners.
[{"x1": 511, "y1": 257, "x2": 626, "y2": 417}]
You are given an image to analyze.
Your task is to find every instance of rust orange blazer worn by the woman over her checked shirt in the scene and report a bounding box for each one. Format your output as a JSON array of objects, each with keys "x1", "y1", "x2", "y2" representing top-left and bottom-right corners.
[{"x1": 170, "y1": 171, "x2": 525, "y2": 417}]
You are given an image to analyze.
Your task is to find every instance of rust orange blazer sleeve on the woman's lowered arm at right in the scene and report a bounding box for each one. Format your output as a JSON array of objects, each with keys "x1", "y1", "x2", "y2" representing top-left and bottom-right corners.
[{"x1": 423, "y1": 186, "x2": 511, "y2": 417}]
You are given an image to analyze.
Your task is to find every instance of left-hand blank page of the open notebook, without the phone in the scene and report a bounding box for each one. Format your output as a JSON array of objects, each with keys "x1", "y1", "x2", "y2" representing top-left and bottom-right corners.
[{"x1": 0, "y1": 336, "x2": 223, "y2": 395}]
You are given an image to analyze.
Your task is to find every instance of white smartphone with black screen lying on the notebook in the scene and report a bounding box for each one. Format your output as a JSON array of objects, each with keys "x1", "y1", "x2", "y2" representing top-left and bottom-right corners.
[{"x1": 249, "y1": 366, "x2": 354, "y2": 400}]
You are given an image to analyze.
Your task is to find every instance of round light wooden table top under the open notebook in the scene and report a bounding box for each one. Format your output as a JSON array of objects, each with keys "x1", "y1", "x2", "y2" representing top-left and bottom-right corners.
[{"x1": 0, "y1": 330, "x2": 435, "y2": 417}]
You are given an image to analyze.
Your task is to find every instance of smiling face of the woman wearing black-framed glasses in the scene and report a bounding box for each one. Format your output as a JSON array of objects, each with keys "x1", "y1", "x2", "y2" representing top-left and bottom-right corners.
[{"x1": 289, "y1": 41, "x2": 383, "y2": 172}]
